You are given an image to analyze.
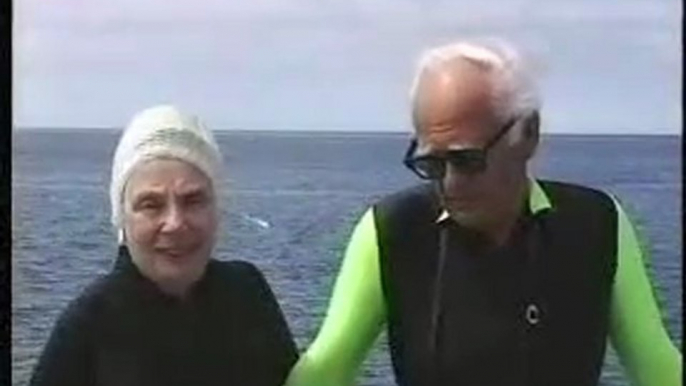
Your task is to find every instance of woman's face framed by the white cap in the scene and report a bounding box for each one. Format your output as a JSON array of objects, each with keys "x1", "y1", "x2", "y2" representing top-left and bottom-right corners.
[{"x1": 123, "y1": 159, "x2": 218, "y2": 295}]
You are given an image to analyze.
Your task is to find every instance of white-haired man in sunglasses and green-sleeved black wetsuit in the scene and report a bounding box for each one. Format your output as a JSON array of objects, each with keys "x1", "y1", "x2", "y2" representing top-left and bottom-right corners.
[{"x1": 287, "y1": 42, "x2": 681, "y2": 386}]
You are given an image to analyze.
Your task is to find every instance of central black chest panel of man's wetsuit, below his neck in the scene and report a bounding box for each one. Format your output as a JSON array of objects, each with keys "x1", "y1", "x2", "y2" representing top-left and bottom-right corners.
[{"x1": 437, "y1": 226, "x2": 526, "y2": 385}]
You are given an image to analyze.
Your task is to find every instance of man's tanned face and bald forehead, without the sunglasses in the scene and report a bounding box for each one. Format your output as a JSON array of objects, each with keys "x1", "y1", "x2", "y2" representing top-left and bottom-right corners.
[{"x1": 414, "y1": 61, "x2": 528, "y2": 228}]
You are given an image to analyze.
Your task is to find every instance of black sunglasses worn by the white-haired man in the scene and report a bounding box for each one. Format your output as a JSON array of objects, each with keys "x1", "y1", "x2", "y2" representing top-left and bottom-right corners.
[{"x1": 403, "y1": 118, "x2": 517, "y2": 180}]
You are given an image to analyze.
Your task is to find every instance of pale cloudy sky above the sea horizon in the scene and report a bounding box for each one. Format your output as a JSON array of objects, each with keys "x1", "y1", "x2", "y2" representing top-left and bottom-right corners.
[{"x1": 13, "y1": 0, "x2": 683, "y2": 134}]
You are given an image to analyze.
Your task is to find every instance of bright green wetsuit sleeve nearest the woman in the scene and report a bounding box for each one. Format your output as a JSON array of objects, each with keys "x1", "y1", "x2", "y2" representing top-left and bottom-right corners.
[{"x1": 286, "y1": 208, "x2": 386, "y2": 386}]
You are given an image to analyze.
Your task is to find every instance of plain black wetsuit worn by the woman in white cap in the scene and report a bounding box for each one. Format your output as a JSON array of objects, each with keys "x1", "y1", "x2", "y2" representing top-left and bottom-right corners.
[{"x1": 31, "y1": 247, "x2": 297, "y2": 386}]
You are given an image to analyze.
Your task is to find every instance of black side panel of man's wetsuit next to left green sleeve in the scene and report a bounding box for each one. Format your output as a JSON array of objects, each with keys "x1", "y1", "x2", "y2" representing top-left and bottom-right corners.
[{"x1": 375, "y1": 186, "x2": 439, "y2": 386}]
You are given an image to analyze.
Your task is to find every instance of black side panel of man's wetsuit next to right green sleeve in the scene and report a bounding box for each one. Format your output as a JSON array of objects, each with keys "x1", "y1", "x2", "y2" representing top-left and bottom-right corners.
[{"x1": 531, "y1": 183, "x2": 617, "y2": 385}]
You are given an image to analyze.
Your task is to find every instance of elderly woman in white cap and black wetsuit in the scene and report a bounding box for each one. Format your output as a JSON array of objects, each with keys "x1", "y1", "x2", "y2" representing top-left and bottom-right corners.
[{"x1": 31, "y1": 106, "x2": 297, "y2": 386}]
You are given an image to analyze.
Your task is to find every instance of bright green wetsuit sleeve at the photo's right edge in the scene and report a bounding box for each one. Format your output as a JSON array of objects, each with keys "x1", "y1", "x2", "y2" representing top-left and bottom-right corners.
[{"x1": 610, "y1": 196, "x2": 682, "y2": 386}]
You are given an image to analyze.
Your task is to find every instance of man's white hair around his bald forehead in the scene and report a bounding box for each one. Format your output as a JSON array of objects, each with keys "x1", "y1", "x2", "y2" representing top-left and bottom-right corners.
[{"x1": 410, "y1": 38, "x2": 541, "y2": 143}]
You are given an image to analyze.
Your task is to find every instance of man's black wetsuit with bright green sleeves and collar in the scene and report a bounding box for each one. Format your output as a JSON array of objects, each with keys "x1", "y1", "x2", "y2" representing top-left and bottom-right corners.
[{"x1": 287, "y1": 180, "x2": 682, "y2": 386}]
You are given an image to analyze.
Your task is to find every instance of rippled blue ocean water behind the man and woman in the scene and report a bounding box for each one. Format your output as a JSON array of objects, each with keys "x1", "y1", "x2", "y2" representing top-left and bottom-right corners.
[{"x1": 12, "y1": 130, "x2": 682, "y2": 386}]
